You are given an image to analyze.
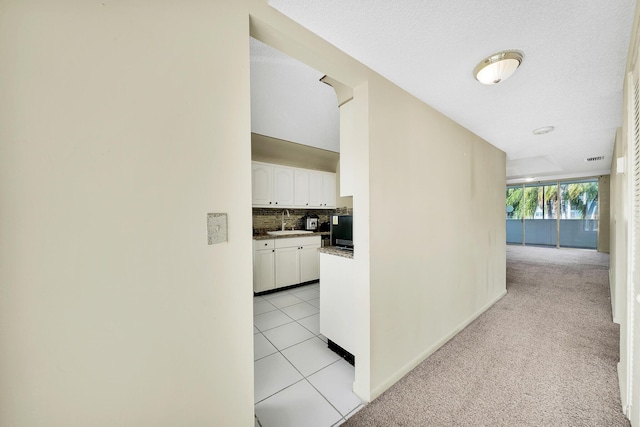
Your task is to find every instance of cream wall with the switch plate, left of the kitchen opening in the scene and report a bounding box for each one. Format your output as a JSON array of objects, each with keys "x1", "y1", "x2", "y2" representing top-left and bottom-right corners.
[{"x1": 0, "y1": 0, "x2": 253, "y2": 427}]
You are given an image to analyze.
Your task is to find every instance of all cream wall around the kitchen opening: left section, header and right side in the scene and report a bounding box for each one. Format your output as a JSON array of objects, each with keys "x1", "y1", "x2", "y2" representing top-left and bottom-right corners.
[{"x1": 0, "y1": 0, "x2": 505, "y2": 427}]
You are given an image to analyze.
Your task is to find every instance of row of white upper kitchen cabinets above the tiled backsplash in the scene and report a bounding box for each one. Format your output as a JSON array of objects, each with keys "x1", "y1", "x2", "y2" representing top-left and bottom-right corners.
[{"x1": 251, "y1": 162, "x2": 336, "y2": 208}]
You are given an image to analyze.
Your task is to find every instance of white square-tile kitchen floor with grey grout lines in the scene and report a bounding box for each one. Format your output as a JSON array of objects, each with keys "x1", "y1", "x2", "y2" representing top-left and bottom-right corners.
[{"x1": 253, "y1": 283, "x2": 363, "y2": 427}]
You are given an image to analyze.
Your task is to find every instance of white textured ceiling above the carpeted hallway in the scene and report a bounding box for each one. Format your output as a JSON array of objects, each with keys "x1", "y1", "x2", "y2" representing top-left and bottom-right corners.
[{"x1": 252, "y1": 0, "x2": 635, "y2": 182}]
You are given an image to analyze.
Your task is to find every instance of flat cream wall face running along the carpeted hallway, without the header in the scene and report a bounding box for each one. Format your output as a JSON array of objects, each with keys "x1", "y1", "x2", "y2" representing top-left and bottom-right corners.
[{"x1": 369, "y1": 74, "x2": 506, "y2": 397}]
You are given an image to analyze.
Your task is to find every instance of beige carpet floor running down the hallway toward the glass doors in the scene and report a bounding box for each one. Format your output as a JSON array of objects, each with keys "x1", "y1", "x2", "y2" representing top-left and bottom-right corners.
[{"x1": 343, "y1": 246, "x2": 629, "y2": 427}]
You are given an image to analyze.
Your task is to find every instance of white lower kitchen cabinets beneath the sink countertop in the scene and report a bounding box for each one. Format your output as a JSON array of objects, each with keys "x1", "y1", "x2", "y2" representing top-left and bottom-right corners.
[{"x1": 253, "y1": 235, "x2": 320, "y2": 292}]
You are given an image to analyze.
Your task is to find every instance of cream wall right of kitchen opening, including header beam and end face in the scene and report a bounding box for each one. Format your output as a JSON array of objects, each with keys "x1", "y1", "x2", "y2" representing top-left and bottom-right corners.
[{"x1": 251, "y1": 1, "x2": 506, "y2": 400}]
